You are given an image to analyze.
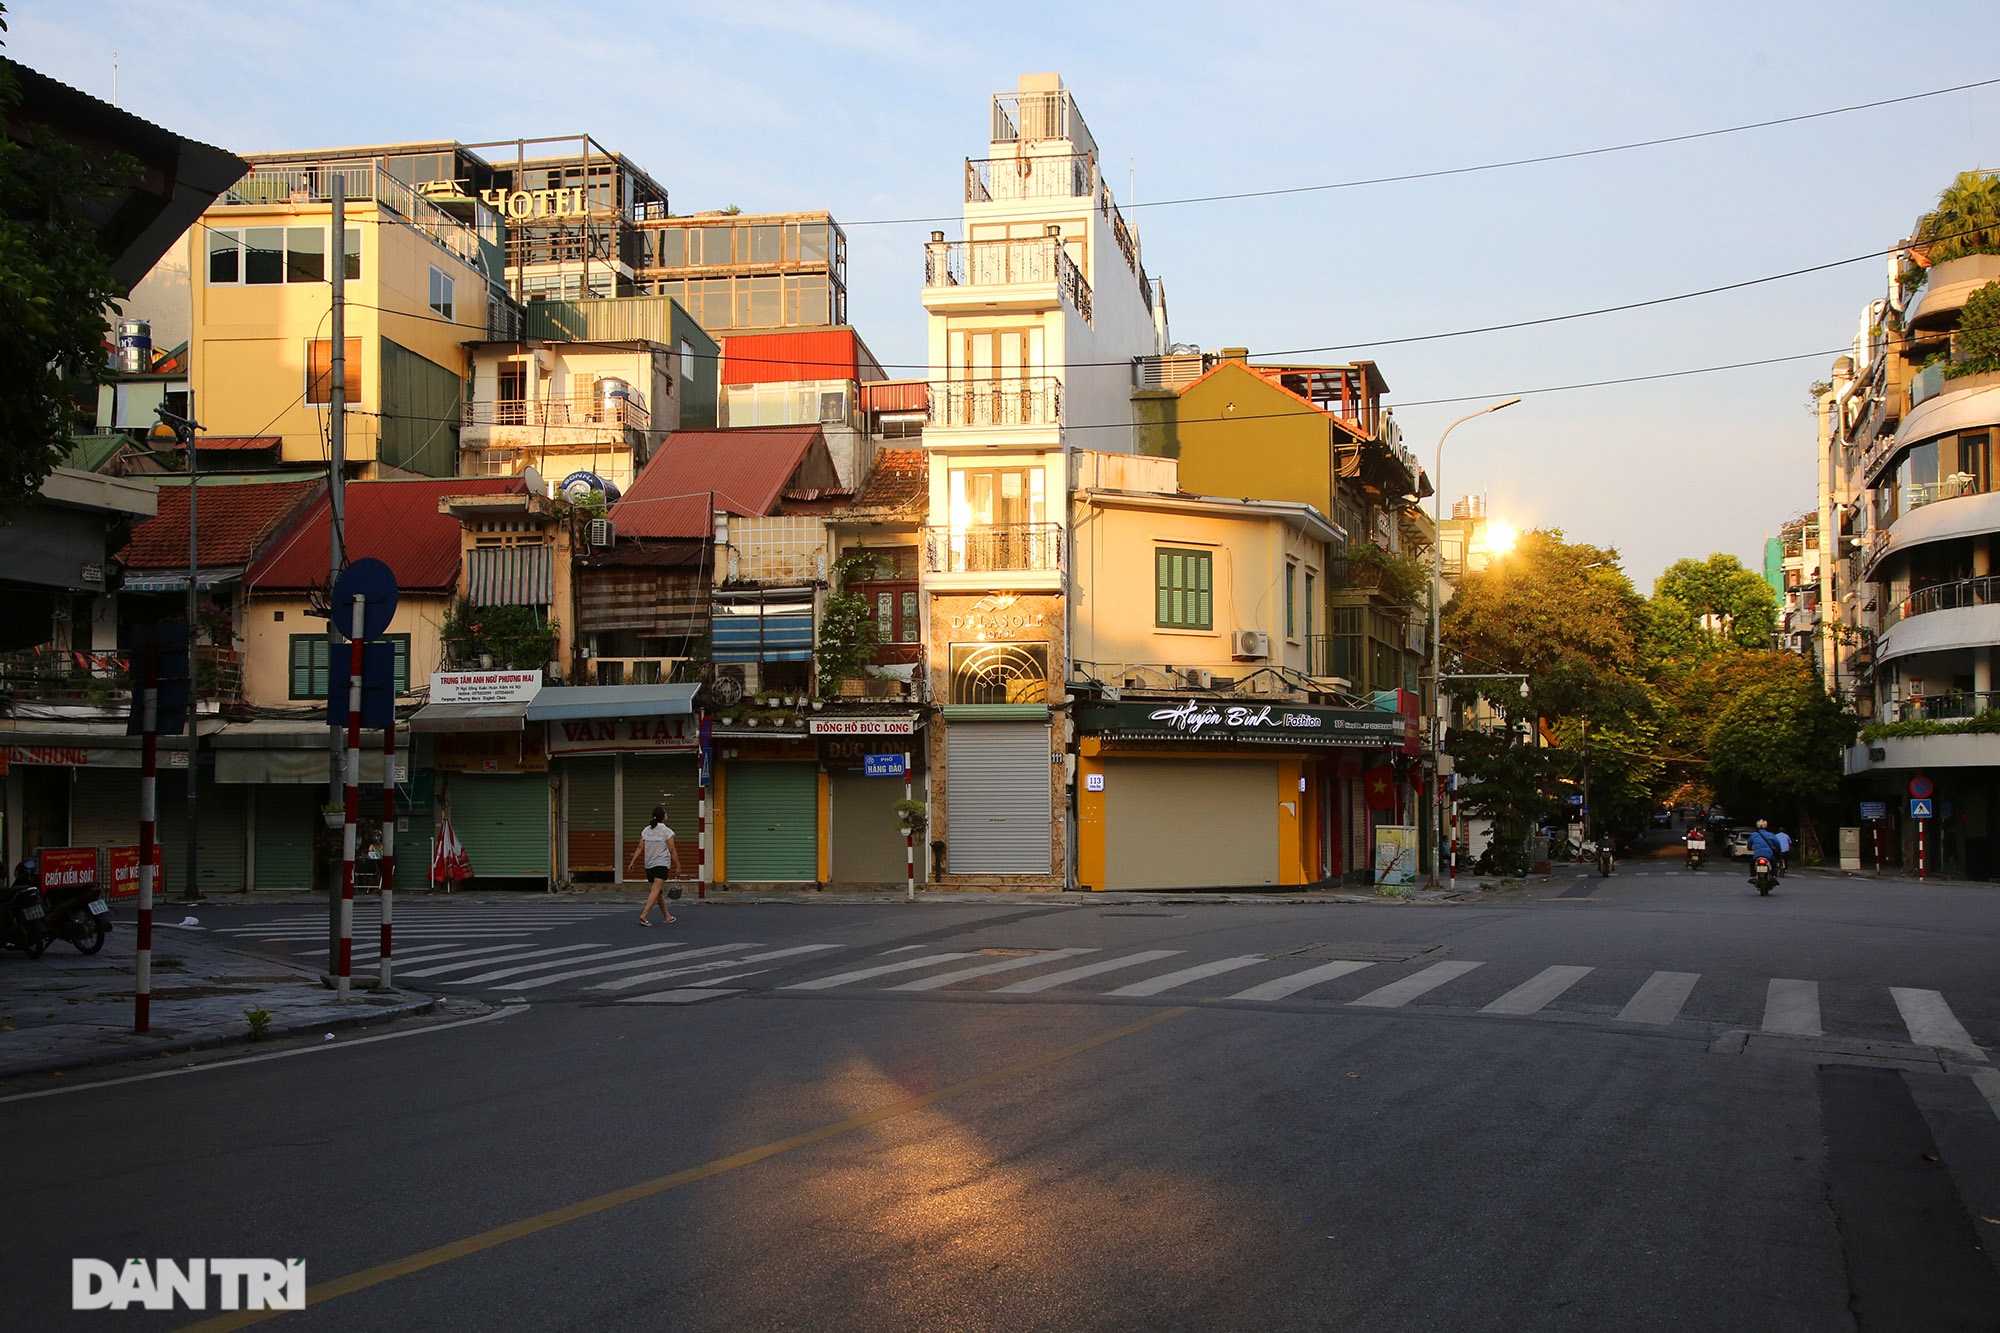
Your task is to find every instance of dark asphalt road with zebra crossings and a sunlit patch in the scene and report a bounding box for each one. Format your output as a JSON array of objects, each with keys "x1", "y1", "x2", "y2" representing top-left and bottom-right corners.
[{"x1": 0, "y1": 863, "x2": 2000, "y2": 1331}]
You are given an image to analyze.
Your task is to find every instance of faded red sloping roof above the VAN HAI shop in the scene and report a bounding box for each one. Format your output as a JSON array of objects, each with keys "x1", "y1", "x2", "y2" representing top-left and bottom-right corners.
[{"x1": 610, "y1": 426, "x2": 840, "y2": 538}]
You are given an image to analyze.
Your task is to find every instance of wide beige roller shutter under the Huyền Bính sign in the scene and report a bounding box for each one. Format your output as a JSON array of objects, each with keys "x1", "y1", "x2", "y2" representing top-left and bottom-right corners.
[{"x1": 1104, "y1": 759, "x2": 1278, "y2": 889}]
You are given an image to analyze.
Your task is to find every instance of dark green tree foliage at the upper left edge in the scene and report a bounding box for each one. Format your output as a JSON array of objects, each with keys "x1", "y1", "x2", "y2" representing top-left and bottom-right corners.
[{"x1": 0, "y1": 19, "x2": 136, "y2": 514}]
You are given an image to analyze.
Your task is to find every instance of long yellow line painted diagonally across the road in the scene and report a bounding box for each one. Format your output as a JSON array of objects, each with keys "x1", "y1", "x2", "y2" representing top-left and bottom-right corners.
[{"x1": 186, "y1": 1005, "x2": 1192, "y2": 1333}]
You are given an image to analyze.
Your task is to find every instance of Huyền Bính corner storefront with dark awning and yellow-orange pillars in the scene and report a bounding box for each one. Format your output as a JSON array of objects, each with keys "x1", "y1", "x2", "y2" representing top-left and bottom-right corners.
[{"x1": 1076, "y1": 699, "x2": 1408, "y2": 889}]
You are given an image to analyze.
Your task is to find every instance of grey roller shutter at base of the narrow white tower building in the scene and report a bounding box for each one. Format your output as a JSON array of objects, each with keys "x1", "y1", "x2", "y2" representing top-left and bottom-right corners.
[{"x1": 944, "y1": 723, "x2": 1052, "y2": 875}]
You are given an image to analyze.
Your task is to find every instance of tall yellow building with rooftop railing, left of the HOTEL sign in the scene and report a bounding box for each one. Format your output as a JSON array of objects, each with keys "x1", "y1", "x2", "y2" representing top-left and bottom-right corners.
[{"x1": 188, "y1": 162, "x2": 518, "y2": 478}]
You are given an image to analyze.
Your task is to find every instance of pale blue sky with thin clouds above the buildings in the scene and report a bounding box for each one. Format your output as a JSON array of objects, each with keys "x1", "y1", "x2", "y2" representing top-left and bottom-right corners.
[{"x1": 8, "y1": 0, "x2": 2000, "y2": 592}]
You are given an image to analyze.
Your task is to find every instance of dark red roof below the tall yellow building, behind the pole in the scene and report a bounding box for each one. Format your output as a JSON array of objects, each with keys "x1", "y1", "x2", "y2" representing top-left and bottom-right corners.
[{"x1": 244, "y1": 476, "x2": 526, "y2": 592}]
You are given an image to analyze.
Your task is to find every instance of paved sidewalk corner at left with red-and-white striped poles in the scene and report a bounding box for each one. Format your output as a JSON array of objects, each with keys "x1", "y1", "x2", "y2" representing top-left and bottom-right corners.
[{"x1": 0, "y1": 903, "x2": 438, "y2": 1079}]
